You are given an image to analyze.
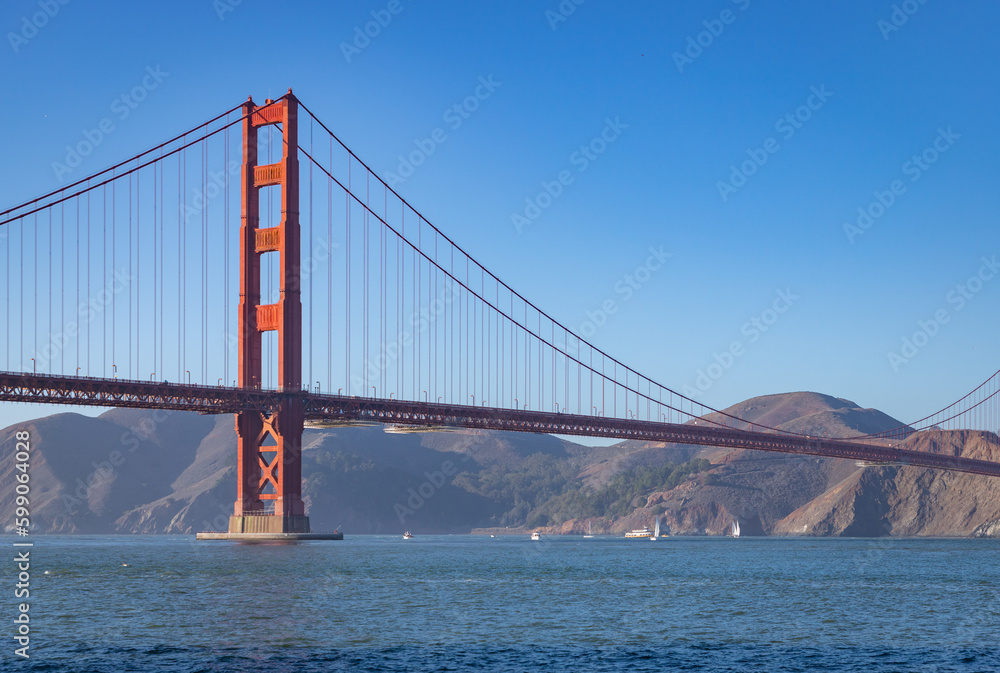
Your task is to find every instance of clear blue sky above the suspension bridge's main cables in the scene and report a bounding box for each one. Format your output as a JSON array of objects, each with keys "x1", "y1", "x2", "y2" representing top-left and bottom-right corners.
[{"x1": 0, "y1": 0, "x2": 1000, "y2": 425}]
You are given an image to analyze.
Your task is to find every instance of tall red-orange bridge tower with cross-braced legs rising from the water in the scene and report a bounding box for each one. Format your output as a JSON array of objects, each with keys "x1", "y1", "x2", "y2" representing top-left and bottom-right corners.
[{"x1": 229, "y1": 89, "x2": 309, "y2": 534}]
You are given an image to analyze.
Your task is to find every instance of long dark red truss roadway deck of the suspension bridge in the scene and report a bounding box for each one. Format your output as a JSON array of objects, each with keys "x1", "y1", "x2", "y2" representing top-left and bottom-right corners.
[{"x1": 7, "y1": 372, "x2": 1000, "y2": 477}]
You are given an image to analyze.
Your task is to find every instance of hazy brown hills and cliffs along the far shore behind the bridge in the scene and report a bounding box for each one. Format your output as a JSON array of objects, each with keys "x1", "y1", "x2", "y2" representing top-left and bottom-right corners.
[{"x1": 0, "y1": 393, "x2": 1000, "y2": 536}]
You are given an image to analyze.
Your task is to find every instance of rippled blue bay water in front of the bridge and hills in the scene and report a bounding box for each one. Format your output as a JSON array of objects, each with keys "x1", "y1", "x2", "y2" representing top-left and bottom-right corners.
[{"x1": 0, "y1": 535, "x2": 1000, "y2": 673}]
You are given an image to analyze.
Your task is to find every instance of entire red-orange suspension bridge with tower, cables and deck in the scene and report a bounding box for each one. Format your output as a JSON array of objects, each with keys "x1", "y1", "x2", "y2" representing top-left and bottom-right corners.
[{"x1": 0, "y1": 90, "x2": 1000, "y2": 536}]
